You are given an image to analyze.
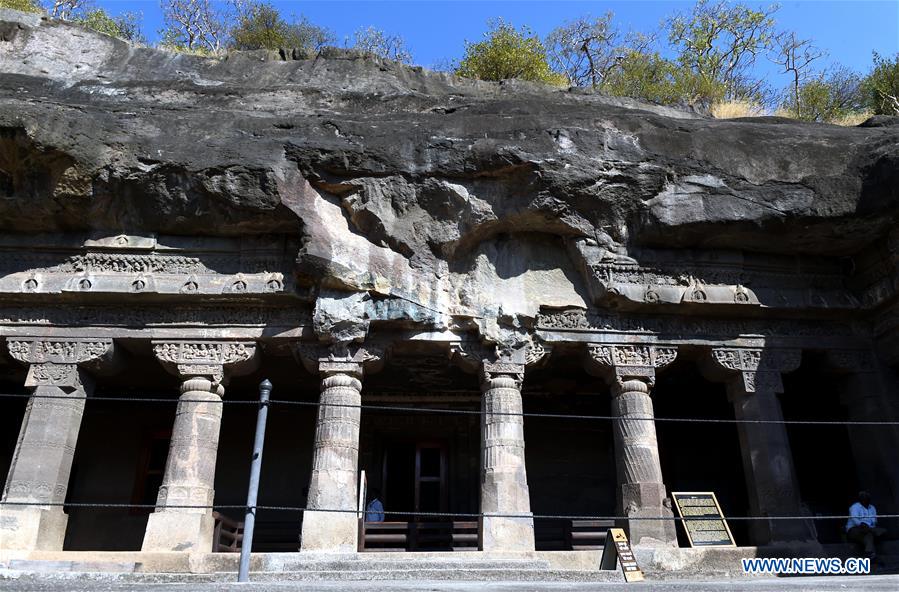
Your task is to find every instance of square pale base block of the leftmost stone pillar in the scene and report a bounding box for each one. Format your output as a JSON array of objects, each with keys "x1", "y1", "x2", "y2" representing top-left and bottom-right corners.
[{"x1": 0, "y1": 506, "x2": 69, "y2": 551}]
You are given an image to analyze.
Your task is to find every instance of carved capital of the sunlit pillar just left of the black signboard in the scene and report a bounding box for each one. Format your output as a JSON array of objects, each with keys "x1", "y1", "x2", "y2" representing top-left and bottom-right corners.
[{"x1": 587, "y1": 343, "x2": 677, "y2": 391}]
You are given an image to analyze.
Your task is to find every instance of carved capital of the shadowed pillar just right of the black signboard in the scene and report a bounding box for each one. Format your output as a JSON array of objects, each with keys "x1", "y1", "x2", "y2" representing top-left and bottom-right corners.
[{"x1": 711, "y1": 347, "x2": 802, "y2": 394}]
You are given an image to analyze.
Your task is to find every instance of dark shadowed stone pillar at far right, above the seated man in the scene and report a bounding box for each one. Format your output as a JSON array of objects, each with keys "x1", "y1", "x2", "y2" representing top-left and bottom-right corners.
[{"x1": 827, "y1": 350, "x2": 899, "y2": 524}]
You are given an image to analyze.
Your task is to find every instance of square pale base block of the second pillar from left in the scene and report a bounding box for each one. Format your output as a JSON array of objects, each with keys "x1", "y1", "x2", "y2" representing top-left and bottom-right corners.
[{"x1": 141, "y1": 510, "x2": 215, "y2": 553}]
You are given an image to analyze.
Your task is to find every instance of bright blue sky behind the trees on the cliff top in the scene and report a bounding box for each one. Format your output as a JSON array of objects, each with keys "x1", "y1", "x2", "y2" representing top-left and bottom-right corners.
[{"x1": 95, "y1": 0, "x2": 899, "y2": 76}]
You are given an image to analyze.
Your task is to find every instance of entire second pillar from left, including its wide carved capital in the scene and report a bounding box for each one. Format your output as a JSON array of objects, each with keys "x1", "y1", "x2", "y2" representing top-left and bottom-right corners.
[{"x1": 141, "y1": 341, "x2": 255, "y2": 553}]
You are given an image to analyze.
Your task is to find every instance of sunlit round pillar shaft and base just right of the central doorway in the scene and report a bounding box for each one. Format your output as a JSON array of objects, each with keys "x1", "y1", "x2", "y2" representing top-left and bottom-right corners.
[{"x1": 480, "y1": 362, "x2": 534, "y2": 551}]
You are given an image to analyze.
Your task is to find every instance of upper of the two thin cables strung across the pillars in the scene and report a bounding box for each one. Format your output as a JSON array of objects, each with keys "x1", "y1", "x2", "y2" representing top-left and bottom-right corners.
[{"x1": 0, "y1": 393, "x2": 899, "y2": 426}]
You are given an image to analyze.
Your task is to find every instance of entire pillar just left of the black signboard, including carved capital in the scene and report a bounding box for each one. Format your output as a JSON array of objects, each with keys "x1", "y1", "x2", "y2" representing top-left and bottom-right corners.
[{"x1": 589, "y1": 345, "x2": 677, "y2": 546}]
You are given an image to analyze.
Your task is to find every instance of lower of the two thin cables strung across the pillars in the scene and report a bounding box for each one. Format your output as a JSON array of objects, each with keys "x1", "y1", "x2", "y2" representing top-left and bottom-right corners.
[{"x1": 0, "y1": 501, "x2": 899, "y2": 521}]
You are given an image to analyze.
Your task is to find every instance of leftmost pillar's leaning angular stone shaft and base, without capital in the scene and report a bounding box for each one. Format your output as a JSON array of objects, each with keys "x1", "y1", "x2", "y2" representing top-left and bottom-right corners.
[{"x1": 0, "y1": 374, "x2": 87, "y2": 551}]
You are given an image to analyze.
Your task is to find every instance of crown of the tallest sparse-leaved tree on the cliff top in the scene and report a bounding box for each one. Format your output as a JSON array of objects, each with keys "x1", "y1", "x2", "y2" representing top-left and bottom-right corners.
[{"x1": 668, "y1": 0, "x2": 777, "y2": 100}]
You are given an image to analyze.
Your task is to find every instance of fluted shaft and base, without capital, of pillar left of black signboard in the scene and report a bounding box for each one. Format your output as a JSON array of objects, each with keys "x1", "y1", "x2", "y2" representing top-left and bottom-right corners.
[{"x1": 612, "y1": 378, "x2": 677, "y2": 545}]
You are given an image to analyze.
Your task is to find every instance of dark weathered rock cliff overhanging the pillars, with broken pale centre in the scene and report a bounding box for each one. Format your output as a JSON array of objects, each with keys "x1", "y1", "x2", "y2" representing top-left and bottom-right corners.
[{"x1": 0, "y1": 11, "x2": 899, "y2": 336}]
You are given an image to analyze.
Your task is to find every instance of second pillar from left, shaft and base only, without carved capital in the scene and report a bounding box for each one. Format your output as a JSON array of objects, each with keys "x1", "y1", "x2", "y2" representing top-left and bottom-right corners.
[{"x1": 142, "y1": 377, "x2": 225, "y2": 553}]
